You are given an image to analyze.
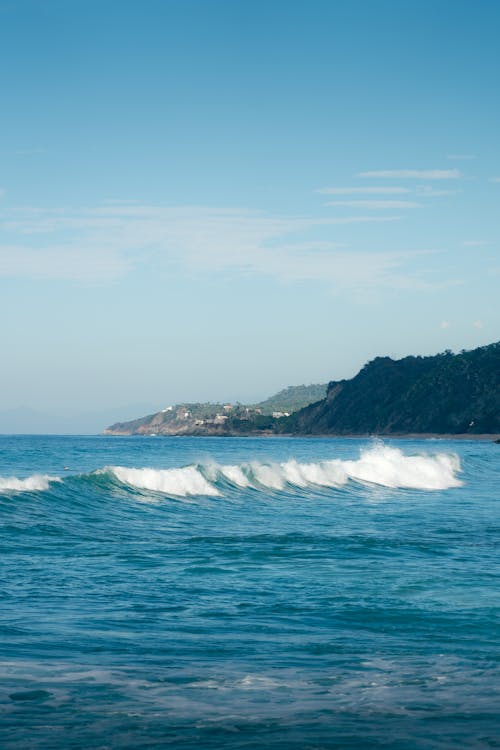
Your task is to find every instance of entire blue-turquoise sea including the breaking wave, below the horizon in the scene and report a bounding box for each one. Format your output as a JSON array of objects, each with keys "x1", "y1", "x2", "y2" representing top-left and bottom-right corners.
[{"x1": 0, "y1": 436, "x2": 500, "y2": 750}]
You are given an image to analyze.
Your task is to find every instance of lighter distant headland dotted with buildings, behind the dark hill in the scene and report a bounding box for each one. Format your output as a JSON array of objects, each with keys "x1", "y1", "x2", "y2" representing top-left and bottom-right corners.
[{"x1": 104, "y1": 384, "x2": 326, "y2": 435}]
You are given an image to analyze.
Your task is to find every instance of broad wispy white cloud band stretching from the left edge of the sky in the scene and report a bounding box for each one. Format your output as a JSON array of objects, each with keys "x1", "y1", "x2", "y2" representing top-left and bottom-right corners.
[{"x1": 0, "y1": 203, "x2": 454, "y2": 296}]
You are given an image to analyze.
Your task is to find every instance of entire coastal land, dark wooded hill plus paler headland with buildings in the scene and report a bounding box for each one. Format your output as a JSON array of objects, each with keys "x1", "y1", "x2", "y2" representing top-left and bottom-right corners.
[{"x1": 105, "y1": 342, "x2": 500, "y2": 436}]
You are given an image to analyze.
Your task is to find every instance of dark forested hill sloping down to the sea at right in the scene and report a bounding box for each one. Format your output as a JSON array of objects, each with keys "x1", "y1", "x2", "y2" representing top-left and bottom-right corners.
[{"x1": 277, "y1": 342, "x2": 500, "y2": 435}]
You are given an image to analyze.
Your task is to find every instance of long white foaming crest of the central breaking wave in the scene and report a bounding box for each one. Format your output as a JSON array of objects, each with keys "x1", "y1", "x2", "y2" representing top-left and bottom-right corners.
[{"x1": 109, "y1": 445, "x2": 461, "y2": 497}]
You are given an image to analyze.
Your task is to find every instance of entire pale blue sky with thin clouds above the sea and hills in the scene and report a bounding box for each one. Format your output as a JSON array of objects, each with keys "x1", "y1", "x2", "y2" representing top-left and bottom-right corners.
[{"x1": 0, "y1": 0, "x2": 500, "y2": 432}]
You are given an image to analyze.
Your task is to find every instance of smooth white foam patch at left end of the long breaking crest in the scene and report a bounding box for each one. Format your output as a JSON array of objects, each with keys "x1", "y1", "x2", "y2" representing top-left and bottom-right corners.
[{"x1": 110, "y1": 466, "x2": 220, "y2": 497}]
